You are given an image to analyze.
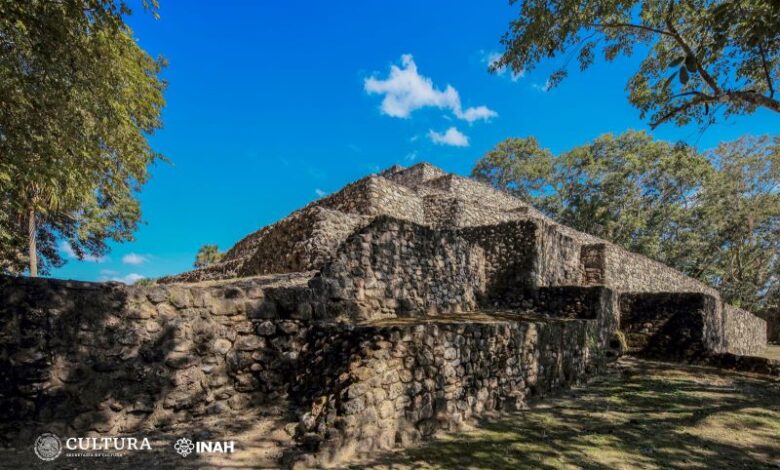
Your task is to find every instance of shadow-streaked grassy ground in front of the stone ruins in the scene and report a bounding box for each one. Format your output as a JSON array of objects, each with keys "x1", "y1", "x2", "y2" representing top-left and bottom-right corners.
[{"x1": 356, "y1": 359, "x2": 780, "y2": 469}]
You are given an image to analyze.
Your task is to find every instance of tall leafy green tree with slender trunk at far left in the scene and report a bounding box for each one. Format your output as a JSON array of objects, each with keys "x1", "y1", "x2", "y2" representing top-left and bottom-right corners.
[{"x1": 0, "y1": 0, "x2": 164, "y2": 276}]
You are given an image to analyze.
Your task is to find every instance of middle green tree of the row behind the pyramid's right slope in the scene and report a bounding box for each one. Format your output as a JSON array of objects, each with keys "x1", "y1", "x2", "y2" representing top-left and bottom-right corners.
[{"x1": 548, "y1": 131, "x2": 712, "y2": 266}]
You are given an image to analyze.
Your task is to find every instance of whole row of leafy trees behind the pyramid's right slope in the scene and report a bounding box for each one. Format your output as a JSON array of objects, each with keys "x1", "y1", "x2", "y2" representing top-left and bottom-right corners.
[{"x1": 473, "y1": 131, "x2": 780, "y2": 310}]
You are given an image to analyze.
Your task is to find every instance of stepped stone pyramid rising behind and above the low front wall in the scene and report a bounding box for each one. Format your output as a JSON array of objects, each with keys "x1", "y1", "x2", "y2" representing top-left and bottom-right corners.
[{"x1": 161, "y1": 163, "x2": 765, "y2": 354}]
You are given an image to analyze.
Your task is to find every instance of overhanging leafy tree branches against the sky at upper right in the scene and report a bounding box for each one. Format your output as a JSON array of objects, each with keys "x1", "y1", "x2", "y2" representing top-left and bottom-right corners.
[{"x1": 491, "y1": 0, "x2": 780, "y2": 126}]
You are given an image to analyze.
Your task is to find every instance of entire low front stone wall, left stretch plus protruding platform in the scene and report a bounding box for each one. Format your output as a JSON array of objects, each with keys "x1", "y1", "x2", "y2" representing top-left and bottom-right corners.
[{"x1": 0, "y1": 274, "x2": 620, "y2": 464}]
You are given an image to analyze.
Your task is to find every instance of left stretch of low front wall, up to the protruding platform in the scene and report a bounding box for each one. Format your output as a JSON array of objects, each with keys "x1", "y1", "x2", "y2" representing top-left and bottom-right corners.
[{"x1": 0, "y1": 277, "x2": 320, "y2": 441}]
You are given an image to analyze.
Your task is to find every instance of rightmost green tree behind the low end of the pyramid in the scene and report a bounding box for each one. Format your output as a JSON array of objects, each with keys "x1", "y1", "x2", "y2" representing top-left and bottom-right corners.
[{"x1": 691, "y1": 137, "x2": 780, "y2": 310}]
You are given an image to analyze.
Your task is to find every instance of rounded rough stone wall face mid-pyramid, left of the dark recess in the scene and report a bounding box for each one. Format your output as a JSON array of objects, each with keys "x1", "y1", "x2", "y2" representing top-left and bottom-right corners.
[{"x1": 310, "y1": 216, "x2": 484, "y2": 320}]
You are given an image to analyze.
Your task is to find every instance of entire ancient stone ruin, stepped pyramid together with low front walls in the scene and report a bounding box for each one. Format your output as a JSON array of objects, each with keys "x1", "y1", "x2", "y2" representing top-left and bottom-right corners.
[{"x1": 0, "y1": 164, "x2": 768, "y2": 461}]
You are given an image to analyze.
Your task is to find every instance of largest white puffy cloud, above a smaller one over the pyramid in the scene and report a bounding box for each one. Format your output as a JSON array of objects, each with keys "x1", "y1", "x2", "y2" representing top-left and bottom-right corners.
[{"x1": 363, "y1": 54, "x2": 498, "y2": 123}]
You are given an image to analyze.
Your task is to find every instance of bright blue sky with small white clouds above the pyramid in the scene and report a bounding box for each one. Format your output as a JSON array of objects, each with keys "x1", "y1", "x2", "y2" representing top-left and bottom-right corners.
[{"x1": 52, "y1": 0, "x2": 780, "y2": 281}]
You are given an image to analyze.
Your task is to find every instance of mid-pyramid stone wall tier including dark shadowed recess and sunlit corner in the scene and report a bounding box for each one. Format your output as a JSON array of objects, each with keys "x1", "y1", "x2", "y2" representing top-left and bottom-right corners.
[{"x1": 310, "y1": 216, "x2": 620, "y2": 320}]
